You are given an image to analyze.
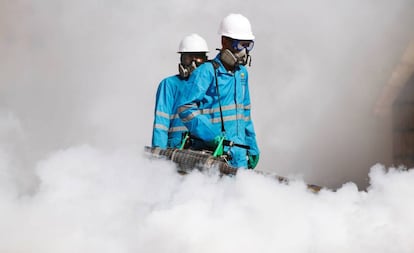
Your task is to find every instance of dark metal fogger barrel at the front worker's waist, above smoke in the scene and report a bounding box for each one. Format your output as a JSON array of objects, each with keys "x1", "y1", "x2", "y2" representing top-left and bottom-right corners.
[{"x1": 145, "y1": 146, "x2": 237, "y2": 175}]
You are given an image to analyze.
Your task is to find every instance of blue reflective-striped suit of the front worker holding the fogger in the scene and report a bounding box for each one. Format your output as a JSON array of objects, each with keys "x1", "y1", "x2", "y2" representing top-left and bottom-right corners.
[{"x1": 178, "y1": 53, "x2": 260, "y2": 168}]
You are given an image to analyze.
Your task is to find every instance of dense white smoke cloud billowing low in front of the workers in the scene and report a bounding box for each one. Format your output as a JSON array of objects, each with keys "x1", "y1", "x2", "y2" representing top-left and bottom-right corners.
[{"x1": 0, "y1": 146, "x2": 414, "y2": 252}]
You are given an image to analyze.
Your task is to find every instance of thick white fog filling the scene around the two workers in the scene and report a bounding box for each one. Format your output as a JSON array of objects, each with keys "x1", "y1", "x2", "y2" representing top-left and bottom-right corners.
[{"x1": 0, "y1": 0, "x2": 414, "y2": 253}]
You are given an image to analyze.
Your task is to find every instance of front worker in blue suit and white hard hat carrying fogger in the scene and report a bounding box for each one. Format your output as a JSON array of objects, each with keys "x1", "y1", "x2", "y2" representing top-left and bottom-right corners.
[{"x1": 178, "y1": 14, "x2": 260, "y2": 169}]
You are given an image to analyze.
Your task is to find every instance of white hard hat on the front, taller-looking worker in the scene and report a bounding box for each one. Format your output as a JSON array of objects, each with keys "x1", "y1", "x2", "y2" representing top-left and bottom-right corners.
[{"x1": 218, "y1": 13, "x2": 254, "y2": 40}]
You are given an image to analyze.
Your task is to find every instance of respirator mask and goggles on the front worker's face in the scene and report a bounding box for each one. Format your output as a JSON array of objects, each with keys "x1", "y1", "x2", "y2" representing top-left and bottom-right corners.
[{"x1": 220, "y1": 39, "x2": 254, "y2": 67}]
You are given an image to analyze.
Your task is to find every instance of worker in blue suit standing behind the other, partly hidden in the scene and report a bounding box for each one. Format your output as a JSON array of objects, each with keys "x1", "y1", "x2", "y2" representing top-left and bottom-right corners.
[{"x1": 152, "y1": 34, "x2": 208, "y2": 149}]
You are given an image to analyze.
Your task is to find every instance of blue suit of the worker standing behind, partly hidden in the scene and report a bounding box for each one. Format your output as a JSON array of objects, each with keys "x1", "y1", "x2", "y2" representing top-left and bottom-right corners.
[{"x1": 152, "y1": 75, "x2": 187, "y2": 148}]
